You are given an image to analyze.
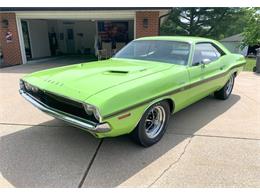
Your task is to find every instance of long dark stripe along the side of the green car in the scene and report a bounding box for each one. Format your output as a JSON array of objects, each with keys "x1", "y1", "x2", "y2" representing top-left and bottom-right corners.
[{"x1": 102, "y1": 63, "x2": 245, "y2": 120}]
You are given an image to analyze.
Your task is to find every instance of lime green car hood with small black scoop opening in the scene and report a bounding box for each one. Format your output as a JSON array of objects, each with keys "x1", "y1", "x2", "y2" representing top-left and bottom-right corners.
[{"x1": 24, "y1": 59, "x2": 172, "y2": 101}]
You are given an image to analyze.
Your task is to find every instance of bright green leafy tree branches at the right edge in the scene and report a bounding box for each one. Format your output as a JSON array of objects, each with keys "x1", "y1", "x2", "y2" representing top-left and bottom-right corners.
[{"x1": 242, "y1": 8, "x2": 260, "y2": 47}]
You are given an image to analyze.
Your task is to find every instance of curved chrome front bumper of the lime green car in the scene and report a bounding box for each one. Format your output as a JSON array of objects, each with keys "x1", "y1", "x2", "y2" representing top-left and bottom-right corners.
[{"x1": 19, "y1": 89, "x2": 111, "y2": 133}]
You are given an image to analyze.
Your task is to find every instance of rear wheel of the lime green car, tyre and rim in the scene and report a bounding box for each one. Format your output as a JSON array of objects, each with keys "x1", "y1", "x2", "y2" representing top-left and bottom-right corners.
[{"x1": 214, "y1": 74, "x2": 235, "y2": 100}]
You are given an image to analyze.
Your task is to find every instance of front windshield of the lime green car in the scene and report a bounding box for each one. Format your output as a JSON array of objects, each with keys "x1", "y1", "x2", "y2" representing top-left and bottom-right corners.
[{"x1": 114, "y1": 40, "x2": 190, "y2": 65}]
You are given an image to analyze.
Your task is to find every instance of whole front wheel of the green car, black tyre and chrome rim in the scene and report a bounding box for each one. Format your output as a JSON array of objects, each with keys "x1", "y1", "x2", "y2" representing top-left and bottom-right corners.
[{"x1": 132, "y1": 101, "x2": 170, "y2": 147}]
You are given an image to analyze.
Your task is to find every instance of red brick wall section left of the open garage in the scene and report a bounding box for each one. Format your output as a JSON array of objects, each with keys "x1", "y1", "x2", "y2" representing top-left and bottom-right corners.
[{"x1": 0, "y1": 13, "x2": 22, "y2": 65}]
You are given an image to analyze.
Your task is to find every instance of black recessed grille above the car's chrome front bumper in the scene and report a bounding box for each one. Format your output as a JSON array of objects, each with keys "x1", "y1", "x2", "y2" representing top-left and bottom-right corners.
[{"x1": 26, "y1": 89, "x2": 98, "y2": 123}]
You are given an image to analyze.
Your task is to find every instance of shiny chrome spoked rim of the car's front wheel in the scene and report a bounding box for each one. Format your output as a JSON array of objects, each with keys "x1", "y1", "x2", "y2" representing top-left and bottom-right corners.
[{"x1": 145, "y1": 105, "x2": 166, "y2": 139}]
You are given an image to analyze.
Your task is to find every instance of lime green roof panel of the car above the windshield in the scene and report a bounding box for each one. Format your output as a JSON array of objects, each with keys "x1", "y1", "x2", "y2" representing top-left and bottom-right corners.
[{"x1": 136, "y1": 36, "x2": 214, "y2": 43}]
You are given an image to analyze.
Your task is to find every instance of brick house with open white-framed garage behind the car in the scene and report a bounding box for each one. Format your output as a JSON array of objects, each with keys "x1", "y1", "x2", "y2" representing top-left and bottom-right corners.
[{"x1": 0, "y1": 8, "x2": 171, "y2": 67}]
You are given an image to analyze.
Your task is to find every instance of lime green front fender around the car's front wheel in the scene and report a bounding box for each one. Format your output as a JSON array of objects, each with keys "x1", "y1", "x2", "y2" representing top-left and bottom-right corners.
[{"x1": 86, "y1": 66, "x2": 189, "y2": 137}]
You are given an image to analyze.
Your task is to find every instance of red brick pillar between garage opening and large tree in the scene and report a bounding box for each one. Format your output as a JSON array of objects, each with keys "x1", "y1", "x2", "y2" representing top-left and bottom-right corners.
[{"x1": 136, "y1": 11, "x2": 159, "y2": 38}]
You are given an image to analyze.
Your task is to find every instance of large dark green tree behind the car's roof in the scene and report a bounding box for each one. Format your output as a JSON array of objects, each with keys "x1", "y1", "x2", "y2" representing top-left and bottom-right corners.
[{"x1": 161, "y1": 8, "x2": 246, "y2": 39}]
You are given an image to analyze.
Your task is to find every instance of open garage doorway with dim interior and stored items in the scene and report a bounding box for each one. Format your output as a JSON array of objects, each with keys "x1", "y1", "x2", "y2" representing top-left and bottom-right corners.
[{"x1": 21, "y1": 19, "x2": 134, "y2": 61}]
